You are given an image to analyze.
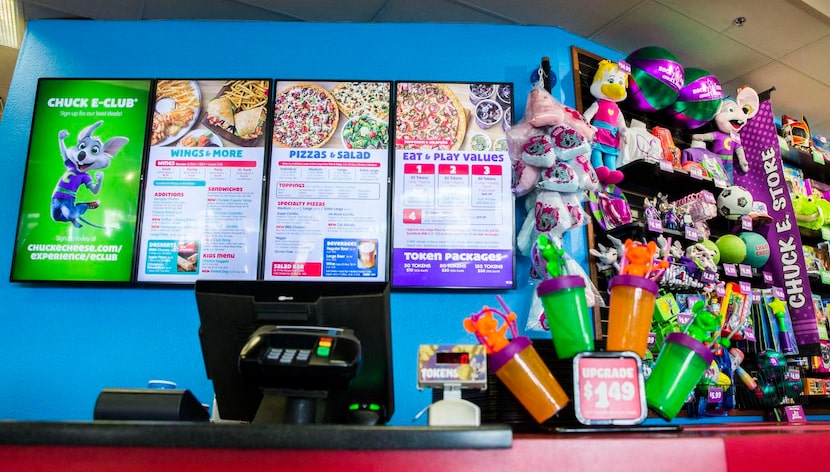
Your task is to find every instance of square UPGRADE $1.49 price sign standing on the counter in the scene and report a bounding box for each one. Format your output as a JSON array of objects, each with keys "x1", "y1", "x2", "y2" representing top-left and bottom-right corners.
[{"x1": 573, "y1": 351, "x2": 648, "y2": 425}]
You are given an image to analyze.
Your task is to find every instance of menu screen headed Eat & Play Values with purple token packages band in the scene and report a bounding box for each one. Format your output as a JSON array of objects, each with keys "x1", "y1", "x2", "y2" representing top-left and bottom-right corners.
[{"x1": 392, "y1": 82, "x2": 514, "y2": 288}]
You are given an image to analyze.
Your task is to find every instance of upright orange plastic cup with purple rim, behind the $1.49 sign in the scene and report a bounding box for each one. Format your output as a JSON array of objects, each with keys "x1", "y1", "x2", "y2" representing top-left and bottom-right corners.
[{"x1": 606, "y1": 274, "x2": 657, "y2": 358}]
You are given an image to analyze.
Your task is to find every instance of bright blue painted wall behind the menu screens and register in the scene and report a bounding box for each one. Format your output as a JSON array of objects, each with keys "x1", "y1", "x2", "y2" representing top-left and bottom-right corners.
[{"x1": 0, "y1": 20, "x2": 621, "y2": 425}]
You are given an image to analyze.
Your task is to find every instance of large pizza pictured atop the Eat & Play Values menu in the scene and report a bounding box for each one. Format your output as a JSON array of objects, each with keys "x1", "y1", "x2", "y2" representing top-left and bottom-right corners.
[{"x1": 395, "y1": 82, "x2": 467, "y2": 151}]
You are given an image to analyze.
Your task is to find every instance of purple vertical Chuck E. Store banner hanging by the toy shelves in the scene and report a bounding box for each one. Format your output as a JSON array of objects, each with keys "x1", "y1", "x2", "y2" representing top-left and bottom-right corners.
[{"x1": 735, "y1": 100, "x2": 819, "y2": 345}]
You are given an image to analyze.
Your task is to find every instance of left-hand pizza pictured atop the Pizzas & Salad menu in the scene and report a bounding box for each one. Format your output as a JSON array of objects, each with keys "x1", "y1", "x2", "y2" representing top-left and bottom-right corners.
[{"x1": 273, "y1": 83, "x2": 340, "y2": 148}]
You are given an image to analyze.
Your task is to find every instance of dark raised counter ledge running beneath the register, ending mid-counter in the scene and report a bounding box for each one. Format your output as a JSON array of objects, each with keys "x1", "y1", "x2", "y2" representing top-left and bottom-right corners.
[{"x1": 0, "y1": 421, "x2": 513, "y2": 450}]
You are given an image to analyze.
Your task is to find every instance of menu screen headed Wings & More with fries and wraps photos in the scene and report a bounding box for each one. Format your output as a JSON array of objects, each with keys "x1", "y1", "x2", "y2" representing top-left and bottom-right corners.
[{"x1": 136, "y1": 79, "x2": 271, "y2": 283}]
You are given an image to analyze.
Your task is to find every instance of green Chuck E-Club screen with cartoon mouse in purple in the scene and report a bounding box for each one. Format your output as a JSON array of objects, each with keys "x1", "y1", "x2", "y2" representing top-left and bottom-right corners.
[{"x1": 11, "y1": 79, "x2": 151, "y2": 282}]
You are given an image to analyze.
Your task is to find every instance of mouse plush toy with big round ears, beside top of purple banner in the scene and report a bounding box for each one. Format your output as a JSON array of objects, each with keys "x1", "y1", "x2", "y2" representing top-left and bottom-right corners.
[{"x1": 692, "y1": 87, "x2": 760, "y2": 183}]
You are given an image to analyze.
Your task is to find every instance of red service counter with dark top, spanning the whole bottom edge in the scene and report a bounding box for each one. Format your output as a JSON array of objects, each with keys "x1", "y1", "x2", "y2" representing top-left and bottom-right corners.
[{"x1": 0, "y1": 422, "x2": 830, "y2": 472}]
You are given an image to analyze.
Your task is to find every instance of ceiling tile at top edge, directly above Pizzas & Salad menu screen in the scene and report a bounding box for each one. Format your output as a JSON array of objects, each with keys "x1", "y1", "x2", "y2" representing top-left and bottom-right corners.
[{"x1": 238, "y1": 0, "x2": 387, "y2": 22}]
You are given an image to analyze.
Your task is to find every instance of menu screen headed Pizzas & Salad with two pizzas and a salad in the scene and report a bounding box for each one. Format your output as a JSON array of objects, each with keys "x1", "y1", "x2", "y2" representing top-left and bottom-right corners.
[{"x1": 263, "y1": 80, "x2": 391, "y2": 282}]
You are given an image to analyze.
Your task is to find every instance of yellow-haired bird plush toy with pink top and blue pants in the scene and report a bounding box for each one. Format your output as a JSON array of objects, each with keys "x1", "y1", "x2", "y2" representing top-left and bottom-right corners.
[{"x1": 584, "y1": 60, "x2": 629, "y2": 184}]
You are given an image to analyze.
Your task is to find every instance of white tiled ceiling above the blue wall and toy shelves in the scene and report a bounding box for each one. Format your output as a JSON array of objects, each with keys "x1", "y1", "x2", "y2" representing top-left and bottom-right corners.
[{"x1": 14, "y1": 0, "x2": 830, "y2": 137}]
